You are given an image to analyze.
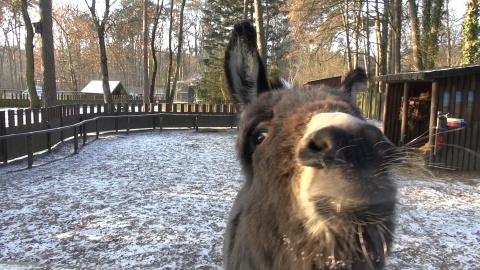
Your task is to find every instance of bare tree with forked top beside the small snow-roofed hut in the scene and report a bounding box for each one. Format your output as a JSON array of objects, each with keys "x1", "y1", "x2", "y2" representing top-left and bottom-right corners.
[{"x1": 85, "y1": 0, "x2": 115, "y2": 104}]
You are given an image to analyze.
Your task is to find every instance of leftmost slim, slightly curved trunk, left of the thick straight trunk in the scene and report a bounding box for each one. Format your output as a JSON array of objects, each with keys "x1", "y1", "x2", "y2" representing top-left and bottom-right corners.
[{"x1": 21, "y1": 0, "x2": 40, "y2": 109}]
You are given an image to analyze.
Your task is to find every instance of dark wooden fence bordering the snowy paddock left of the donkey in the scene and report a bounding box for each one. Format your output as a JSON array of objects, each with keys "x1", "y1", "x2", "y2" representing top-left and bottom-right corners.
[{"x1": 0, "y1": 104, "x2": 237, "y2": 166}]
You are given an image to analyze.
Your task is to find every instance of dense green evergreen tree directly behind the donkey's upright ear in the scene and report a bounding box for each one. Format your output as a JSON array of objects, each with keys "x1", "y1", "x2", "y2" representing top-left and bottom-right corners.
[{"x1": 197, "y1": 0, "x2": 290, "y2": 103}]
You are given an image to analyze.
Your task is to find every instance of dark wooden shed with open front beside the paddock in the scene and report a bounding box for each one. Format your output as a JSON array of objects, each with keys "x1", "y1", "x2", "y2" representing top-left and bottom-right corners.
[{"x1": 379, "y1": 65, "x2": 480, "y2": 170}]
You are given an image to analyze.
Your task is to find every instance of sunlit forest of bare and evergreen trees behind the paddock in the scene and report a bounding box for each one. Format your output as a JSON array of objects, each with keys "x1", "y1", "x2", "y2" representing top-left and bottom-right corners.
[{"x1": 0, "y1": 0, "x2": 480, "y2": 107}]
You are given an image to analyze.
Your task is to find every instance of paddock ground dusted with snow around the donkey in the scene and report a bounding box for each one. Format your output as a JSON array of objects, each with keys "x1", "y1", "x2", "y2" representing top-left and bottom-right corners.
[{"x1": 0, "y1": 129, "x2": 480, "y2": 269}]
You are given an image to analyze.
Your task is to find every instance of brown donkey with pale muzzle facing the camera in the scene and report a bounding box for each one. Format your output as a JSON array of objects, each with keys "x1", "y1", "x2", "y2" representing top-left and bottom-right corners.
[{"x1": 224, "y1": 22, "x2": 397, "y2": 269}]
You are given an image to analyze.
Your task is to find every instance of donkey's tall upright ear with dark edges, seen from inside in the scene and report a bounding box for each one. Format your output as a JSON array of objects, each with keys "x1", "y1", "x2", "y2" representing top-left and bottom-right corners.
[{"x1": 224, "y1": 22, "x2": 270, "y2": 112}]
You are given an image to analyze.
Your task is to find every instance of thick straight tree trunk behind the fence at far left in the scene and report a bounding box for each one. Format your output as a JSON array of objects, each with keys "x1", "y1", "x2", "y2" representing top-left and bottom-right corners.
[{"x1": 39, "y1": 0, "x2": 57, "y2": 108}]
